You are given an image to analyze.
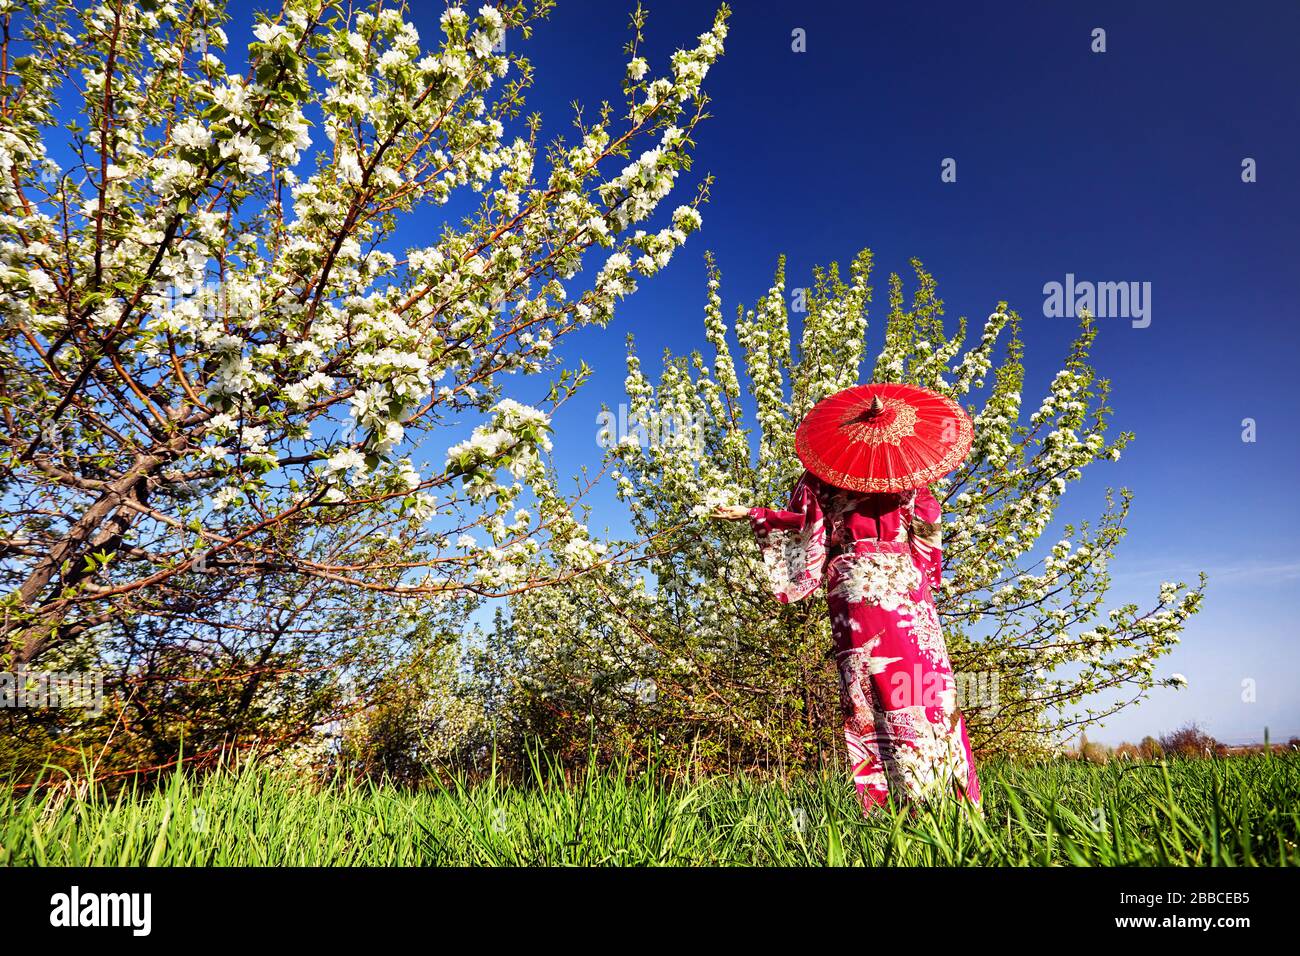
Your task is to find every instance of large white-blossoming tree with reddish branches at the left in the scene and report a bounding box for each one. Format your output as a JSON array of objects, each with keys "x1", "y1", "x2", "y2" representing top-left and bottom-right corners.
[{"x1": 0, "y1": 0, "x2": 728, "y2": 666}]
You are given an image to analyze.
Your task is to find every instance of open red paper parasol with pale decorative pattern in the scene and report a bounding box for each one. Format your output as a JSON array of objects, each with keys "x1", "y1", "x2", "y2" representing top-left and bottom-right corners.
[{"x1": 794, "y1": 382, "x2": 972, "y2": 492}]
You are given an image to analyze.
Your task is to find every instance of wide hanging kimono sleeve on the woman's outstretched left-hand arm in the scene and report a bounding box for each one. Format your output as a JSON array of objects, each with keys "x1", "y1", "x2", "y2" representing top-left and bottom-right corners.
[{"x1": 749, "y1": 475, "x2": 826, "y2": 604}]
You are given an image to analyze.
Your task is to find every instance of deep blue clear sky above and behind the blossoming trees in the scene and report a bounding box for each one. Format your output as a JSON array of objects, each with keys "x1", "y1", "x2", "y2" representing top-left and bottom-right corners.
[{"x1": 210, "y1": 0, "x2": 1300, "y2": 743}]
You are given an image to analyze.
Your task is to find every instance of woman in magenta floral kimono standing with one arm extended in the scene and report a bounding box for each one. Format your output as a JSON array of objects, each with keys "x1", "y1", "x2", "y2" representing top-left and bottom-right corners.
[{"x1": 714, "y1": 472, "x2": 980, "y2": 816}]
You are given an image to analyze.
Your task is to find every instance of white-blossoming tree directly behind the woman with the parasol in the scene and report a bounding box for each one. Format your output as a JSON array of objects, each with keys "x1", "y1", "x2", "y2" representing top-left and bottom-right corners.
[{"x1": 488, "y1": 251, "x2": 1204, "y2": 766}]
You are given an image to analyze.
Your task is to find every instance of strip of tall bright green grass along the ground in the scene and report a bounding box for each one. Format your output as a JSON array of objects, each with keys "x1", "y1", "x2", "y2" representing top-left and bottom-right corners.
[{"x1": 0, "y1": 753, "x2": 1300, "y2": 866}]
